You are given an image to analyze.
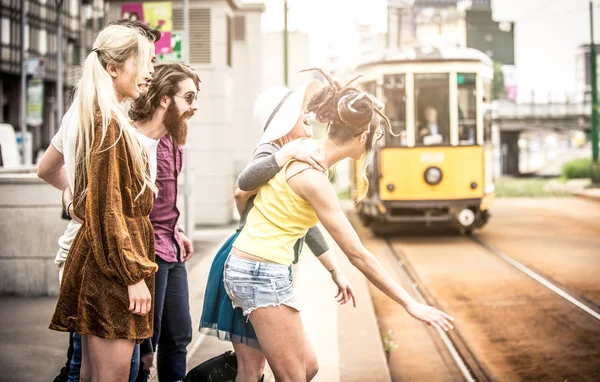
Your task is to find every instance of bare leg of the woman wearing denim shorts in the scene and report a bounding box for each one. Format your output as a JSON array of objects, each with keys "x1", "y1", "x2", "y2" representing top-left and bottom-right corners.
[{"x1": 250, "y1": 305, "x2": 306, "y2": 382}]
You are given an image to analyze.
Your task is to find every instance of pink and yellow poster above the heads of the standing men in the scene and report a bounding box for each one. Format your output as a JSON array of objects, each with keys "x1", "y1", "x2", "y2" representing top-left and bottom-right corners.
[{"x1": 121, "y1": 1, "x2": 173, "y2": 54}]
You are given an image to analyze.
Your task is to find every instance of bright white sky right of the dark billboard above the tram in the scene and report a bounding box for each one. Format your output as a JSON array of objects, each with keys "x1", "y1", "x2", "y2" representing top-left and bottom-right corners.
[{"x1": 492, "y1": 0, "x2": 600, "y2": 103}]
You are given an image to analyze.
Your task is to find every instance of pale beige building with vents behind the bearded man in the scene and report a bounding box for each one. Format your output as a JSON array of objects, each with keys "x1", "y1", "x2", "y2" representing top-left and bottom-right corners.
[{"x1": 107, "y1": 0, "x2": 264, "y2": 227}]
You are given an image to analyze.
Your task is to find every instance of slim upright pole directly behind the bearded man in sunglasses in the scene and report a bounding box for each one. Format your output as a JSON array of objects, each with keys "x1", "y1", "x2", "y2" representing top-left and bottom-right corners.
[{"x1": 181, "y1": 0, "x2": 196, "y2": 236}]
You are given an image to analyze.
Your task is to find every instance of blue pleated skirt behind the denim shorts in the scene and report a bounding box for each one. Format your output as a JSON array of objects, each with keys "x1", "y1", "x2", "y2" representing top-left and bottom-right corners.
[{"x1": 200, "y1": 232, "x2": 260, "y2": 349}]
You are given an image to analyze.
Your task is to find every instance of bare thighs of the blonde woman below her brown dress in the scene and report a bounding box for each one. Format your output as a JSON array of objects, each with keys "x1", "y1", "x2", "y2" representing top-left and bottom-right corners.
[{"x1": 84, "y1": 335, "x2": 134, "y2": 382}]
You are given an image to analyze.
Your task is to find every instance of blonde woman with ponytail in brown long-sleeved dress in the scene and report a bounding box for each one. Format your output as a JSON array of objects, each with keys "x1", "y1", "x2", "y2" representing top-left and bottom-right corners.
[{"x1": 50, "y1": 25, "x2": 157, "y2": 382}]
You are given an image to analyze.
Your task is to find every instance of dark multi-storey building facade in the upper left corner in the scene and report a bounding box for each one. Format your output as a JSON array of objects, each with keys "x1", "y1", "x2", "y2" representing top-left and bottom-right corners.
[{"x1": 0, "y1": 0, "x2": 105, "y2": 164}]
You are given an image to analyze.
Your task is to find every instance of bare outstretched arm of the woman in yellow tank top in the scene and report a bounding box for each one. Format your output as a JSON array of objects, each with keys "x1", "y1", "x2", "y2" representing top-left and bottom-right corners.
[{"x1": 288, "y1": 164, "x2": 453, "y2": 330}]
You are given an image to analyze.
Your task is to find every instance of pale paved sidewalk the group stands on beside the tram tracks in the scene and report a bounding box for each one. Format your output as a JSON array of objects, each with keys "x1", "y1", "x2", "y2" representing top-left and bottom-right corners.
[{"x1": 0, "y1": 227, "x2": 389, "y2": 382}]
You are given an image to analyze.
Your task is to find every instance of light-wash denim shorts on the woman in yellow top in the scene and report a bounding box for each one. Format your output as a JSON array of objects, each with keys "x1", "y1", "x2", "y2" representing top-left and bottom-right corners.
[{"x1": 223, "y1": 255, "x2": 300, "y2": 316}]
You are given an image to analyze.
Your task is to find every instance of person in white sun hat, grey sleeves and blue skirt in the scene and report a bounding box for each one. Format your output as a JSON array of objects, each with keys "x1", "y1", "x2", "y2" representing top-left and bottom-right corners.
[{"x1": 196, "y1": 80, "x2": 356, "y2": 382}]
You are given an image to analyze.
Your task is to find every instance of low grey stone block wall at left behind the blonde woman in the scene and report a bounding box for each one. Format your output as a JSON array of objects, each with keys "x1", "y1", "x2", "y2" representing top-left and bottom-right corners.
[{"x1": 0, "y1": 169, "x2": 67, "y2": 296}]
